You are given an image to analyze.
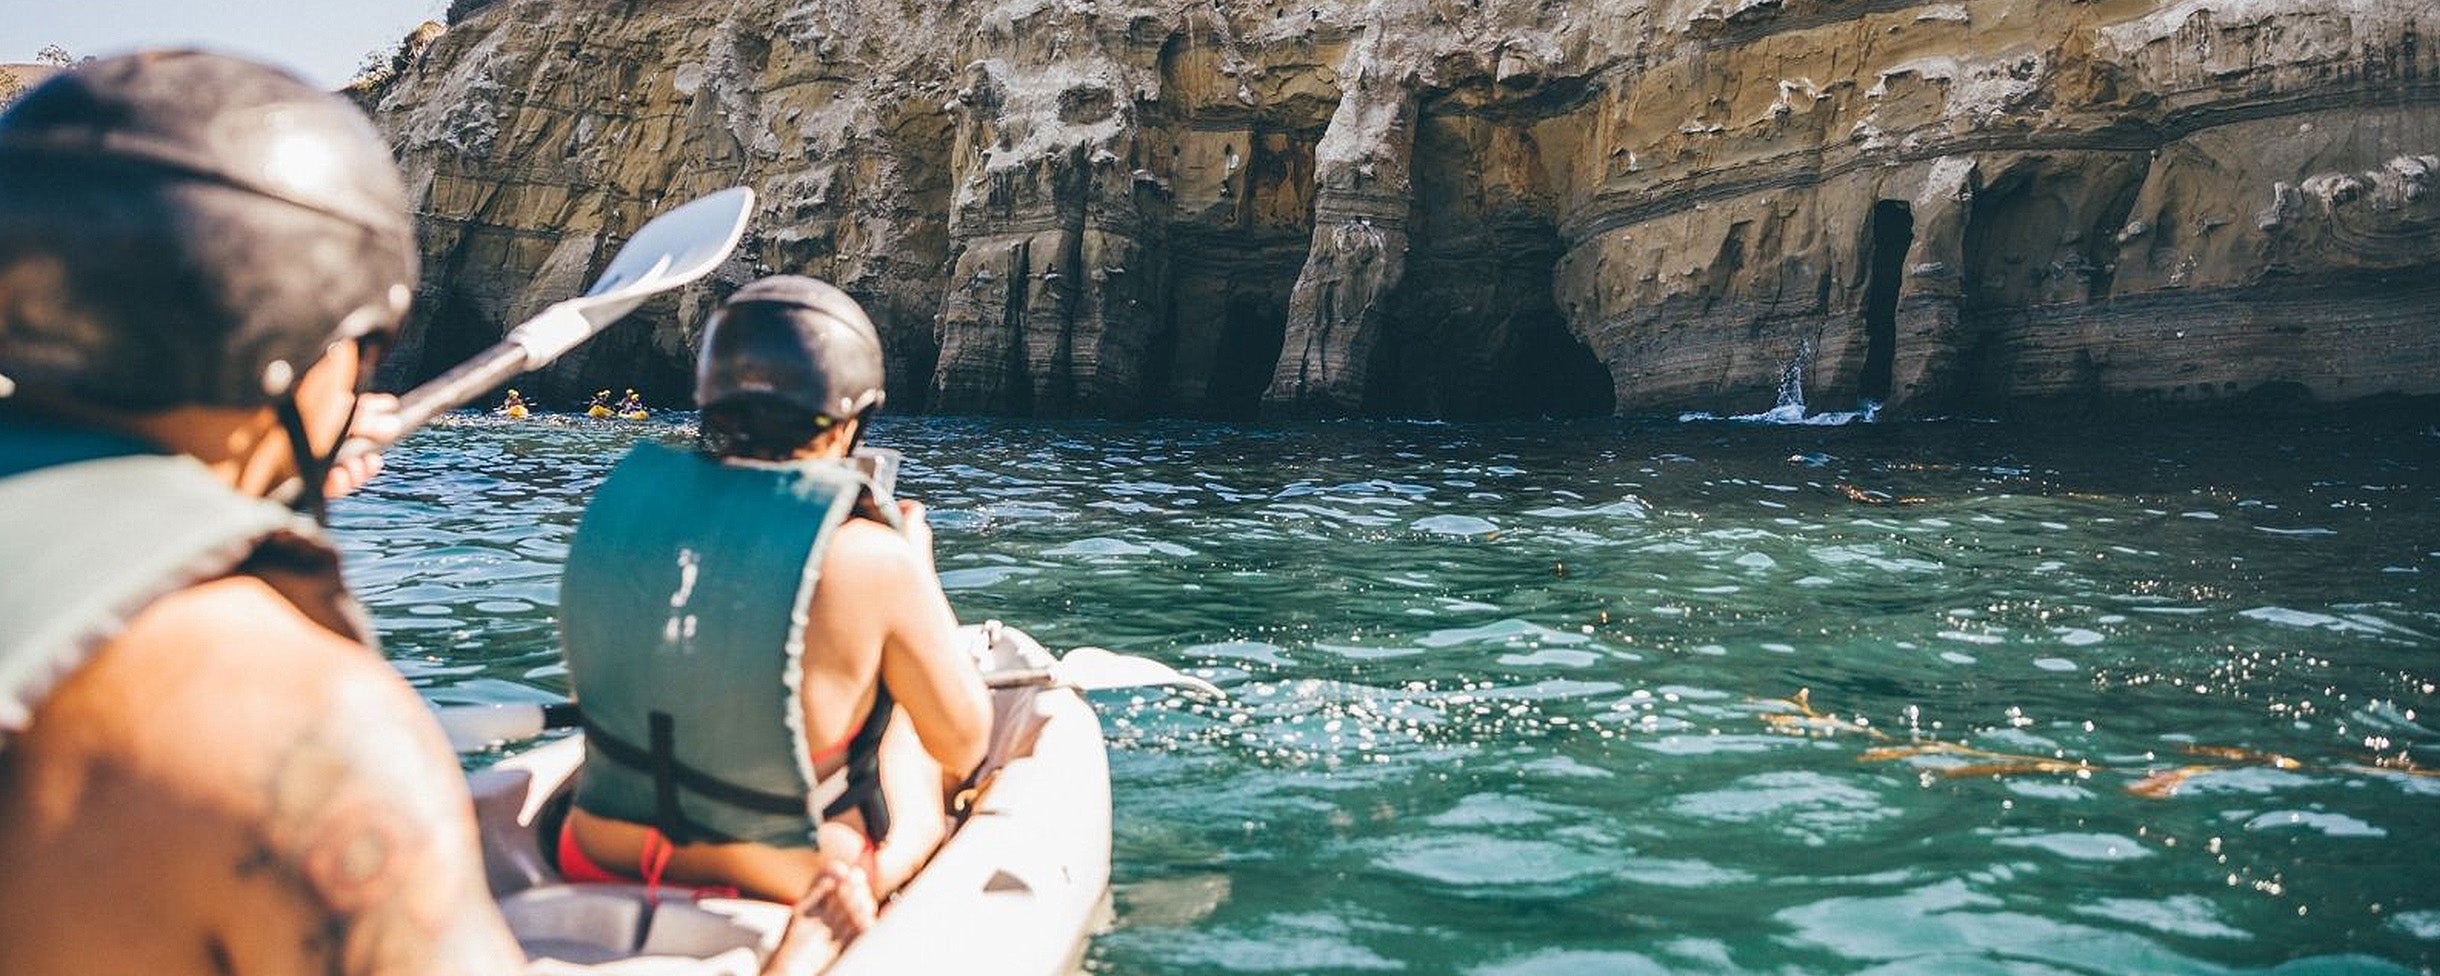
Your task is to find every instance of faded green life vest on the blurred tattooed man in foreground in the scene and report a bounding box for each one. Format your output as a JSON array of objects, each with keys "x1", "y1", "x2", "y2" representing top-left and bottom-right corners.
[{"x1": 0, "y1": 417, "x2": 371, "y2": 747}]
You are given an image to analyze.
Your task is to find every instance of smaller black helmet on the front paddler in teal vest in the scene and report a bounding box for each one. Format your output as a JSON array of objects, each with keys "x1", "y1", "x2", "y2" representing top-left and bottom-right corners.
[{"x1": 695, "y1": 276, "x2": 886, "y2": 456}]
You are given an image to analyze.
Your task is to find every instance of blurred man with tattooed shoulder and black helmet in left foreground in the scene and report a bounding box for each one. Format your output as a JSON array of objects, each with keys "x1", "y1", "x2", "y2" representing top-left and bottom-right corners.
[{"x1": 0, "y1": 51, "x2": 520, "y2": 976}]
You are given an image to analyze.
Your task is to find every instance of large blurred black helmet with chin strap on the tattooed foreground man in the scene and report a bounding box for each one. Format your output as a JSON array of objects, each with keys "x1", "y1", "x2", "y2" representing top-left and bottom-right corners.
[{"x1": 0, "y1": 51, "x2": 417, "y2": 522}]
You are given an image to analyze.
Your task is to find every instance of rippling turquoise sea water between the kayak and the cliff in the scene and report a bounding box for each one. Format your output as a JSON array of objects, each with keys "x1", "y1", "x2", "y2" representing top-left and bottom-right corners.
[{"x1": 334, "y1": 417, "x2": 2440, "y2": 974}]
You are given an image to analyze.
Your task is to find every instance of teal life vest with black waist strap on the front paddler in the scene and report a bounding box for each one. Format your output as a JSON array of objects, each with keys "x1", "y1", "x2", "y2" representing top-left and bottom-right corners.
[{"x1": 559, "y1": 444, "x2": 895, "y2": 847}]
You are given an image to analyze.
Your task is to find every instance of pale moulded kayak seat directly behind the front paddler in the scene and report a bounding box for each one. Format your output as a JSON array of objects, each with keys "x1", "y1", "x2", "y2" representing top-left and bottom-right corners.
[{"x1": 500, "y1": 883, "x2": 791, "y2": 976}]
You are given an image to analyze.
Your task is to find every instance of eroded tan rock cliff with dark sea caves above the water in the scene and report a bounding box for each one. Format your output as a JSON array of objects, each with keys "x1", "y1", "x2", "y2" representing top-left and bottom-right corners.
[{"x1": 378, "y1": 0, "x2": 2440, "y2": 417}]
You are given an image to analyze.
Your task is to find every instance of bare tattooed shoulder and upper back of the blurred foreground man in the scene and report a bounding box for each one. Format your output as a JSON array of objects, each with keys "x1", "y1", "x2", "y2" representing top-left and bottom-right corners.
[{"x1": 0, "y1": 578, "x2": 522, "y2": 976}]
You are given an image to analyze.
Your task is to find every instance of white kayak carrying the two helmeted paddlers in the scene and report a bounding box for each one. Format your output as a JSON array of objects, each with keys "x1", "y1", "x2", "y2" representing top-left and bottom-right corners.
[{"x1": 468, "y1": 629, "x2": 1110, "y2": 976}]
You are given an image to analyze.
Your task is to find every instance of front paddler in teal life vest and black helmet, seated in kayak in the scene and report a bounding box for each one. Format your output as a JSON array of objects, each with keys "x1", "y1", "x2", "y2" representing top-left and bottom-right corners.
[{"x1": 556, "y1": 276, "x2": 991, "y2": 939}]
